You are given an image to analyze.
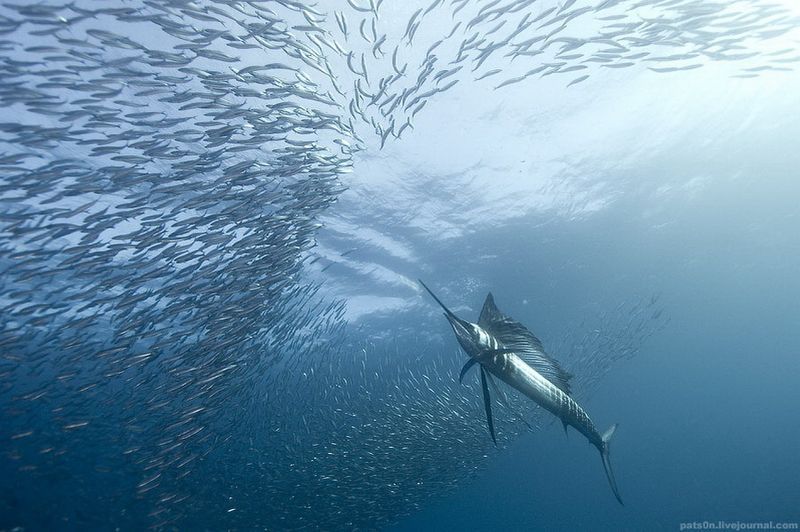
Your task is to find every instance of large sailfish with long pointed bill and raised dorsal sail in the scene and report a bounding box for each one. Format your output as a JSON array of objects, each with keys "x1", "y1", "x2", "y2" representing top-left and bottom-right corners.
[{"x1": 420, "y1": 280, "x2": 623, "y2": 504}]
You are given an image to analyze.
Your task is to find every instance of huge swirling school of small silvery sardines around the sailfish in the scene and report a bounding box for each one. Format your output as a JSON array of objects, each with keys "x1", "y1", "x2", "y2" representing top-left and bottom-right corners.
[{"x1": 0, "y1": 0, "x2": 800, "y2": 529}]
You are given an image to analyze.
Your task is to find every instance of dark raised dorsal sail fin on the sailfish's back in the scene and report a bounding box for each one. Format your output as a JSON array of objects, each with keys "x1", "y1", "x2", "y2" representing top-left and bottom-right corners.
[{"x1": 478, "y1": 292, "x2": 572, "y2": 394}]
